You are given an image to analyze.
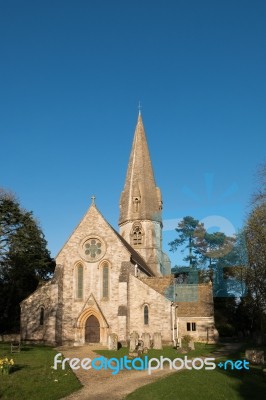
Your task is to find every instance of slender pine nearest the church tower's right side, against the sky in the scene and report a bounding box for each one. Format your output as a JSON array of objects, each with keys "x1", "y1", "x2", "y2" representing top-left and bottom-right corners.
[{"x1": 169, "y1": 216, "x2": 205, "y2": 267}]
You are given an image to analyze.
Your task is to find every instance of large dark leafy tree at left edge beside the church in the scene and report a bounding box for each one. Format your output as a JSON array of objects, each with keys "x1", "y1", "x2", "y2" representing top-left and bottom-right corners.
[{"x1": 0, "y1": 190, "x2": 55, "y2": 332}]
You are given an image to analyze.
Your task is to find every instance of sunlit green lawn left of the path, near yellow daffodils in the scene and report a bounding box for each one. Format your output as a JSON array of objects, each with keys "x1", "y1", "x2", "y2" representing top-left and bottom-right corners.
[{"x1": 0, "y1": 343, "x2": 81, "y2": 400}]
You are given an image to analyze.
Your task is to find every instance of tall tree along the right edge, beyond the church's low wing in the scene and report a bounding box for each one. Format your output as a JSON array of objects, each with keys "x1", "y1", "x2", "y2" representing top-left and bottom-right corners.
[{"x1": 214, "y1": 164, "x2": 266, "y2": 333}]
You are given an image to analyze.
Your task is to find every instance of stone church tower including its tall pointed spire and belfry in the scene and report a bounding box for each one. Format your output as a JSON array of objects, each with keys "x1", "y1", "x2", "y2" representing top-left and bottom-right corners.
[{"x1": 119, "y1": 113, "x2": 166, "y2": 276}]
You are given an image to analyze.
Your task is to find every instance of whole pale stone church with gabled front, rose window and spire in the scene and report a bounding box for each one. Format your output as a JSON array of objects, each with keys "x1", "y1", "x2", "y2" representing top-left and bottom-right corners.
[{"x1": 21, "y1": 113, "x2": 215, "y2": 345}]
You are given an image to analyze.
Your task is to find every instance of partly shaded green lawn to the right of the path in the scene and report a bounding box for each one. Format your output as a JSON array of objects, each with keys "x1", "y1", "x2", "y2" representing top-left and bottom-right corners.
[{"x1": 126, "y1": 344, "x2": 266, "y2": 400}]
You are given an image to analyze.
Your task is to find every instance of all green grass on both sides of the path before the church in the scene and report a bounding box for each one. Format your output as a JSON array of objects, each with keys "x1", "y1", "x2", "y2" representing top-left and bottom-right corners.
[{"x1": 0, "y1": 343, "x2": 266, "y2": 400}]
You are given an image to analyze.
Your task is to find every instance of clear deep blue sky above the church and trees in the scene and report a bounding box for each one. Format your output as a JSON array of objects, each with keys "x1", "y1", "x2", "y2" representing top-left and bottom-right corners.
[{"x1": 0, "y1": 0, "x2": 266, "y2": 262}]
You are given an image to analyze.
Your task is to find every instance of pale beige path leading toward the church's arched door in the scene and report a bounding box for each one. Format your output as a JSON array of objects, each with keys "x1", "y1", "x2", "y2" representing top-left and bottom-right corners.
[{"x1": 57, "y1": 343, "x2": 240, "y2": 400}]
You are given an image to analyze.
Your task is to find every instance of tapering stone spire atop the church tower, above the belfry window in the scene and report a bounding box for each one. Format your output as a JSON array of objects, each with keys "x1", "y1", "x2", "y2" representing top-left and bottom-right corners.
[{"x1": 119, "y1": 110, "x2": 162, "y2": 226}]
